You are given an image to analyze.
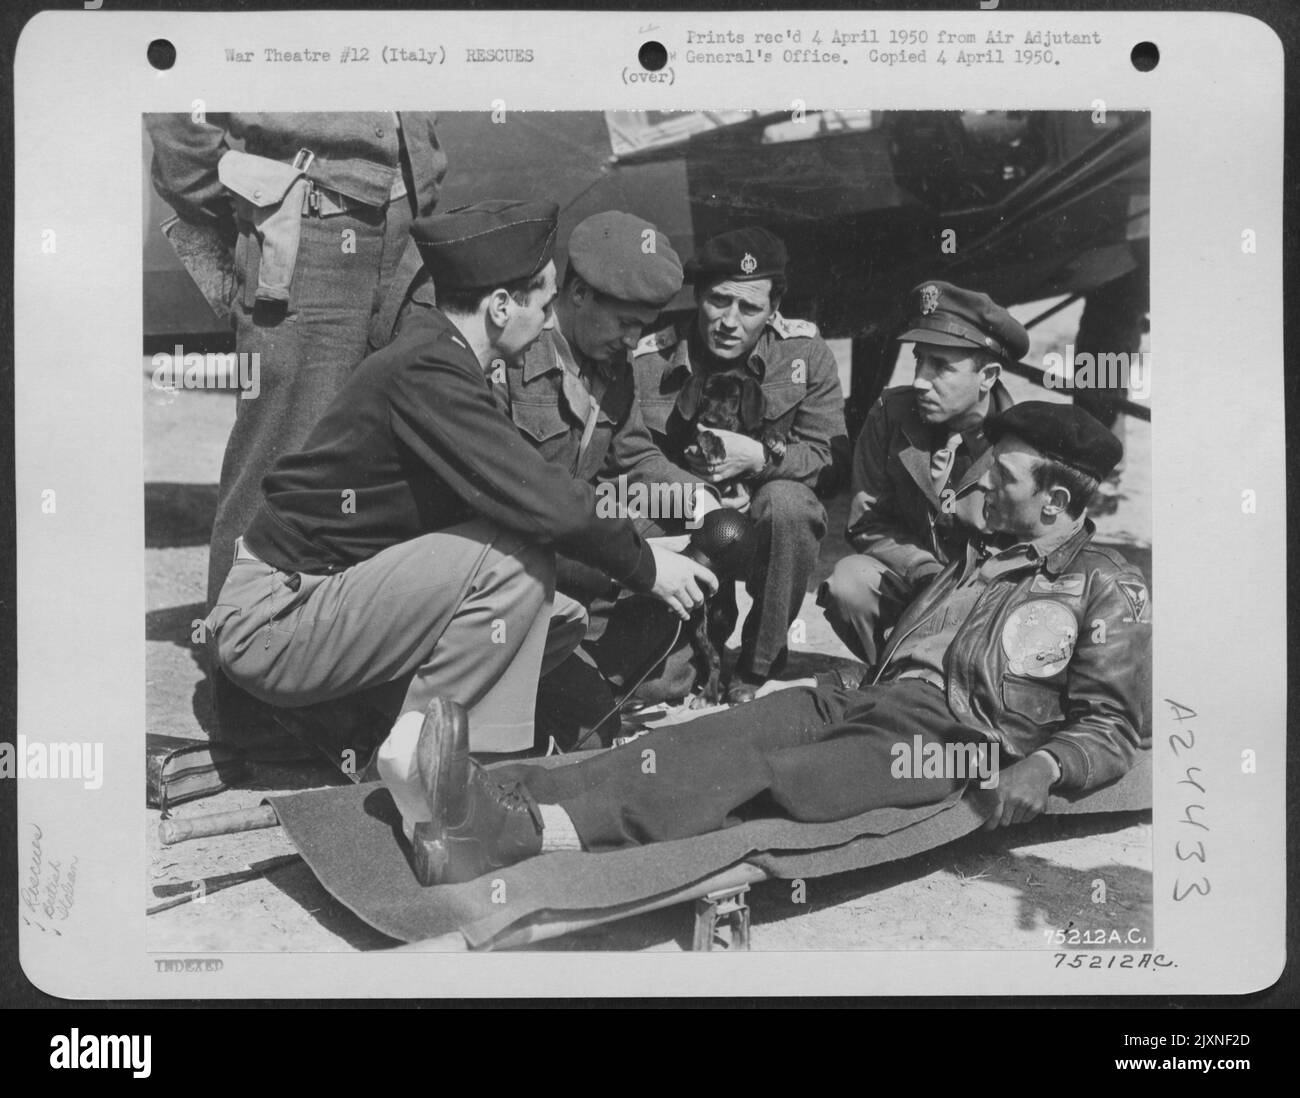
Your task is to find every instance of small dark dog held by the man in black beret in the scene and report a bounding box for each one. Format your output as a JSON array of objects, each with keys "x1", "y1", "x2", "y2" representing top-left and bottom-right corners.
[{"x1": 679, "y1": 374, "x2": 784, "y2": 708}]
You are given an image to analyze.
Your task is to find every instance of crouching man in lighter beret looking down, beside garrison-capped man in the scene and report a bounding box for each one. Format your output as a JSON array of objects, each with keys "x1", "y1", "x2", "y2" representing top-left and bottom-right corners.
[{"x1": 493, "y1": 211, "x2": 719, "y2": 747}]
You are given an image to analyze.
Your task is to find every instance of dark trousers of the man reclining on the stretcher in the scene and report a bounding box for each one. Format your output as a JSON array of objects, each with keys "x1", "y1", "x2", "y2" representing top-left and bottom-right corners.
[{"x1": 493, "y1": 678, "x2": 978, "y2": 851}]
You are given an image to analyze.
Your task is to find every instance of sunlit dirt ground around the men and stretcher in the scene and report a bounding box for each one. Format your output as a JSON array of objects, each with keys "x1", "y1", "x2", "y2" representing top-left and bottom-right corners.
[{"x1": 143, "y1": 308, "x2": 1153, "y2": 952}]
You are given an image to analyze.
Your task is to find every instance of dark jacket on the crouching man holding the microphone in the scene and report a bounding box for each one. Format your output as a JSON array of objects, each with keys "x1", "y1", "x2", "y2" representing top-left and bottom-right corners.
[{"x1": 246, "y1": 309, "x2": 655, "y2": 590}]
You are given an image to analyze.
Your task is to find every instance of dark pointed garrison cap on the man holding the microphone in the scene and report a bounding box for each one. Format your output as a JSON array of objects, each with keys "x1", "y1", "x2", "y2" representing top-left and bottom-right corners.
[{"x1": 411, "y1": 199, "x2": 559, "y2": 290}]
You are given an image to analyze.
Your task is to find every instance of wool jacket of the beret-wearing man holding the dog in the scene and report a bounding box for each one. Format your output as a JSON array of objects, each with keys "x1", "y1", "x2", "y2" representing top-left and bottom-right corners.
[{"x1": 632, "y1": 313, "x2": 848, "y2": 489}]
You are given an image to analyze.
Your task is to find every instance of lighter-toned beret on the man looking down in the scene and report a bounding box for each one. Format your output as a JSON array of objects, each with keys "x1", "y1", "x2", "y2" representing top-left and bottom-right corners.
[{"x1": 569, "y1": 209, "x2": 681, "y2": 309}]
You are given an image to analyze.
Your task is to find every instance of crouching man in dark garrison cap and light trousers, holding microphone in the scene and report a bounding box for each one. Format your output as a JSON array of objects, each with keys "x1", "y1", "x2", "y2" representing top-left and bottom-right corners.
[{"x1": 208, "y1": 201, "x2": 716, "y2": 830}]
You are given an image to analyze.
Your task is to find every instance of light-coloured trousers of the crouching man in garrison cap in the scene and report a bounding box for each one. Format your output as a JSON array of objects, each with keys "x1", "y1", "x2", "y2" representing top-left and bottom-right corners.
[{"x1": 207, "y1": 520, "x2": 586, "y2": 752}]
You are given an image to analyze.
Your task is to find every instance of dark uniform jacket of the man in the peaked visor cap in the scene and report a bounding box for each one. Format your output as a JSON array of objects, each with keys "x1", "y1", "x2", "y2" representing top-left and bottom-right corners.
[{"x1": 845, "y1": 381, "x2": 1014, "y2": 580}]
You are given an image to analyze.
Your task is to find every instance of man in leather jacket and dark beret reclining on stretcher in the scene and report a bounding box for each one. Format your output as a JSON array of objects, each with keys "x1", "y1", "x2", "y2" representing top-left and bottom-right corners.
[{"x1": 392, "y1": 402, "x2": 1151, "y2": 884}]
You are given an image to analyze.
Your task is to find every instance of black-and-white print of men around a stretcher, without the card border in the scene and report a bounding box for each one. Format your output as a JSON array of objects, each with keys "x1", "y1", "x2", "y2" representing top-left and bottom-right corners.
[{"x1": 143, "y1": 108, "x2": 1156, "y2": 952}]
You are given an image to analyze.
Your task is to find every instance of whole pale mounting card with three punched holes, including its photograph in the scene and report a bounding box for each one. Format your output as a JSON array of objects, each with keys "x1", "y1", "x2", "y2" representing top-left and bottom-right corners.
[{"x1": 10, "y1": 5, "x2": 1286, "y2": 999}]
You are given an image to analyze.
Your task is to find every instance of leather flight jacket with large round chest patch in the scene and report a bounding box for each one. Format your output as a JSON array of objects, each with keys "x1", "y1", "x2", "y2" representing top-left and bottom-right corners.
[{"x1": 872, "y1": 520, "x2": 1152, "y2": 790}]
